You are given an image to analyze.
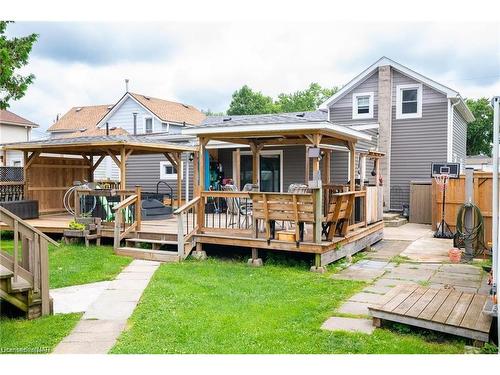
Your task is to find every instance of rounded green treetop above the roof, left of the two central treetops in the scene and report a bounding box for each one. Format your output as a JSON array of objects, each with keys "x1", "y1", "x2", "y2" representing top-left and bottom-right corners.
[{"x1": 227, "y1": 85, "x2": 278, "y2": 115}]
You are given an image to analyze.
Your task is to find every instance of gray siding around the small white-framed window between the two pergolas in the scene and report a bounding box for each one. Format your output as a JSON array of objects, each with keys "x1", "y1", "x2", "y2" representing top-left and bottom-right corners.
[{"x1": 127, "y1": 153, "x2": 193, "y2": 199}]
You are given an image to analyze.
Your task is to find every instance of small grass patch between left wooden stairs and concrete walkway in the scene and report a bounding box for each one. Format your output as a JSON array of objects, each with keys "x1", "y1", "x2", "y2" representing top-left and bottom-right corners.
[{"x1": 0, "y1": 232, "x2": 132, "y2": 288}]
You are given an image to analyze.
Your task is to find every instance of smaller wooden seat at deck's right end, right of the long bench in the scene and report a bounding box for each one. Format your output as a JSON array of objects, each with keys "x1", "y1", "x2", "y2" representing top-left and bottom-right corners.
[{"x1": 323, "y1": 191, "x2": 356, "y2": 241}]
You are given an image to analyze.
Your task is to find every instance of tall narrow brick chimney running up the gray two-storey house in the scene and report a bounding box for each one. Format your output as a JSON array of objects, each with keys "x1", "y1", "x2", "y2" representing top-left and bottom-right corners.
[{"x1": 378, "y1": 65, "x2": 392, "y2": 211}]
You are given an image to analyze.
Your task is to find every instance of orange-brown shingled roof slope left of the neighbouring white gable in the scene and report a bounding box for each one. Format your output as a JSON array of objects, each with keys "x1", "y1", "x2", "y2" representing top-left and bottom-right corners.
[{"x1": 47, "y1": 104, "x2": 112, "y2": 132}]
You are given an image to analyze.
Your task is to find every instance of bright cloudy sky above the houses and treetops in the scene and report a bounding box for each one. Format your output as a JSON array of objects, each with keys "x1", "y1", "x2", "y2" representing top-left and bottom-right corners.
[{"x1": 4, "y1": 21, "x2": 500, "y2": 132}]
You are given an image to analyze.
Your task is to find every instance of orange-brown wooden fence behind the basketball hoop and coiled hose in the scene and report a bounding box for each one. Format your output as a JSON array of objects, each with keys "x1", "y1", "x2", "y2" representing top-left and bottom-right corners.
[{"x1": 432, "y1": 171, "x2": 493, "y2": 244}]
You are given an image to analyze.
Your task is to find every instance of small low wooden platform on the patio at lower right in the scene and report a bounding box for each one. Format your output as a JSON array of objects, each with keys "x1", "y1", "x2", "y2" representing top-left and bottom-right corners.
[{"x1": 369, "y1": 285, "x2": 492, "y2": 342}]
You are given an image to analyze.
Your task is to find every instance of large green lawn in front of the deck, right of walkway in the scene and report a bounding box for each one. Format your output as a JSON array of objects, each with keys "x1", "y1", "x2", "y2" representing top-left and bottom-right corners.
[{"x1": 112, "y1": 259, "x2": 464, "y2": 353}]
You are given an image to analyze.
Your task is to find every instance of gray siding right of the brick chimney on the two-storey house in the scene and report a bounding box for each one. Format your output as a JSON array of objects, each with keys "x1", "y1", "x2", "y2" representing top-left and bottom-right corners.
[{"x1": 390, "y1": 69, "x2": 448, "y2": 210}]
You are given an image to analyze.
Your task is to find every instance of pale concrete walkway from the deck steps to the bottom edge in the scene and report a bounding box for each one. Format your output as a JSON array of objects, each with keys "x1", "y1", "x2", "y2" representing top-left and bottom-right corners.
[{"x1": 54, "y1": 260, "x2": 160, "y2": 354}]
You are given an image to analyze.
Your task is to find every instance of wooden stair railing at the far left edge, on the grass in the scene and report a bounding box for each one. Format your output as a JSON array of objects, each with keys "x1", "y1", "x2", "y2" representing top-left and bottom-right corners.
[{"x1": 0, "y1": 206, "x2": 59, "y2": 315}]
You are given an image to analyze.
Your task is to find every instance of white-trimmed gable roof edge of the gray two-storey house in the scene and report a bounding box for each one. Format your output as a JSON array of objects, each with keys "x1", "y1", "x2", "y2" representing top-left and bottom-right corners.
[{"x1": 319, "y1": 56, "x2": 474, "y2": 122}]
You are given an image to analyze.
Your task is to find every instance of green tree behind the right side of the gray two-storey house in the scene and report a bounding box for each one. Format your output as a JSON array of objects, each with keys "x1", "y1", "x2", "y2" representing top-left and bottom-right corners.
[{"x1": 465, "y1": 98, "x2": 493, "y2": 156}]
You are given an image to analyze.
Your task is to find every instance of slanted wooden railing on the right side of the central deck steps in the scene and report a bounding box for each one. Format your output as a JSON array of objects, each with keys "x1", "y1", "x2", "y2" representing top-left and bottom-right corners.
[{"x1": 174, "y1": 197, "x2": 201, "y2": 258}]
